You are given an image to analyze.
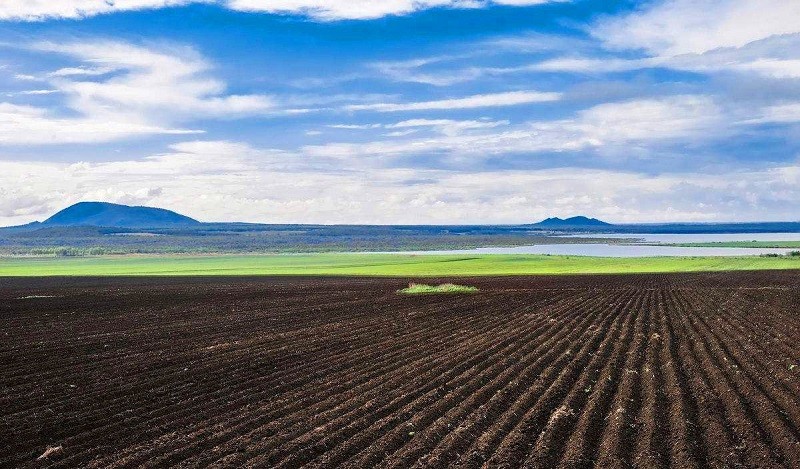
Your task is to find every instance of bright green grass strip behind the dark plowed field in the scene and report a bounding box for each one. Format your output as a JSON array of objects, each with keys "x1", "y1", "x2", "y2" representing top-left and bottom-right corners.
[{"x1": 0, "y1": 254, "x2": 800, "y2": 277}]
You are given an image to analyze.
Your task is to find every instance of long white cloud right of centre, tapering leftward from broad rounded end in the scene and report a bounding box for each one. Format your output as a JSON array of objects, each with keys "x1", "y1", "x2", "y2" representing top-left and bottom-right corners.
[{"x1": 304, "y1": 95, "x2": 726, "y2": 160}]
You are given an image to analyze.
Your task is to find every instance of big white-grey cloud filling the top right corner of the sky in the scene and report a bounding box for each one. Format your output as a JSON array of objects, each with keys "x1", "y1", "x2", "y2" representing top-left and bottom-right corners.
[{"x1": 494, "y1": 5, "x2": 800, "y2": 79}]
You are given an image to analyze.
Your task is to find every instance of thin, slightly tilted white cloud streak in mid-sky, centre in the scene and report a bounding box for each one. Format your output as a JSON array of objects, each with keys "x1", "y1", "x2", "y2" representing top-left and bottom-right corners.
[{"x1": 343, "y1": 91, "x2": 561, "y2": 112}]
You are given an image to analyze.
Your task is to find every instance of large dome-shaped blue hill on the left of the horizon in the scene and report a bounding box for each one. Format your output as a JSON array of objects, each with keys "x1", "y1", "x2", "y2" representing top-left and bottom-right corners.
[{"x1": 39, "y1": 202, "x2": 200, "y2": 228}]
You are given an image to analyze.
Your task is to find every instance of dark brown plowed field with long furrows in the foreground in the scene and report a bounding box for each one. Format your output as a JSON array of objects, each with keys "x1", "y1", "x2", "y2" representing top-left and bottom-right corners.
[{"x1": 0, "y1": 271, "x2": 800, "y2": 468}]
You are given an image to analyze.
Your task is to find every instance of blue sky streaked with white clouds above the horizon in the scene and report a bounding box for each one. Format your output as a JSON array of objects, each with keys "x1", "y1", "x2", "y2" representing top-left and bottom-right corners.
[{"x1": 0, "y1": 0, "x2": 800, "y2": 225}]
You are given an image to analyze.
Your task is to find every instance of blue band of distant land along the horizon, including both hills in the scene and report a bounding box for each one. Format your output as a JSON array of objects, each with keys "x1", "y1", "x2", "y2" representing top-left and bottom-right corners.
[{"x1": 0, "y1": 202, "x2": 800, "y2": 236}]
